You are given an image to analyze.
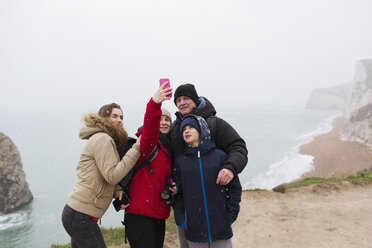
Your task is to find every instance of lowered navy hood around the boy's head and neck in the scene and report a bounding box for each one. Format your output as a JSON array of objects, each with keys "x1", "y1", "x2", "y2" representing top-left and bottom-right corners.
[{"x1": 185, "y1": 114, "x2": 216, "y2": 153}]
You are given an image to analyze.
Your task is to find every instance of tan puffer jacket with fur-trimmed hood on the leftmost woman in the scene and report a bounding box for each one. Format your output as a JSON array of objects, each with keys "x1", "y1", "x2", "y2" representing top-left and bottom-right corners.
[{"x1": 67, "y1": 113, "x2": 140, "y2": 219}]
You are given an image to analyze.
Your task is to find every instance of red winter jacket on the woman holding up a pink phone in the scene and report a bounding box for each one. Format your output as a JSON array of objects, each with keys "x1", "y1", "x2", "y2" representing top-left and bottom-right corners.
[{"x1": 126, "y1": 98, "x2": 172, "y2": 220}]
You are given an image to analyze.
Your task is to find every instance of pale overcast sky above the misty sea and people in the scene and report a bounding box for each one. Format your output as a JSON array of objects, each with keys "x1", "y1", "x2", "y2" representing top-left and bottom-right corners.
[{"x1": 0, "y1": 0, "x2": 372, "y2": 107}]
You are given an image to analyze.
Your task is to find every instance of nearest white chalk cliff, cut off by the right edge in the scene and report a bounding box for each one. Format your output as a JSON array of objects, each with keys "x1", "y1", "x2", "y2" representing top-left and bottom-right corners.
[{"x1": 341, "y1": 60, "x2": 372, "y2": 147}]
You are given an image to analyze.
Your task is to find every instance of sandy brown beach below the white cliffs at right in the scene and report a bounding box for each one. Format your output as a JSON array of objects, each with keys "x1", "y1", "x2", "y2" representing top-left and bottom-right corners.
[{"x1": 299, "y1": 117, "x2": 372, "y2": 178}]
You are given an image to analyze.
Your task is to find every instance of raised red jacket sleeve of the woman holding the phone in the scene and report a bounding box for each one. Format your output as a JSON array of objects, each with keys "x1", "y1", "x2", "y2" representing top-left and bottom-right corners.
[{"x1": 138, "y1": 98, "x2": 162, "y2": 159}]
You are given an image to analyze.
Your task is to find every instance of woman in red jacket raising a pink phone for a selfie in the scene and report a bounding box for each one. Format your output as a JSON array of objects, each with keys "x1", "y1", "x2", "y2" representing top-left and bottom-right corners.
[{"x1": 124, "y1": 83, "x2": 172, "y2": 248}]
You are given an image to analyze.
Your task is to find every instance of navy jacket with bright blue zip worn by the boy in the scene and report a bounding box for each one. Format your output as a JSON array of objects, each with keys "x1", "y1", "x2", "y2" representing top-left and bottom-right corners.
[{"x1": 174, "y1": 116, "x2": 242, "y2": 242}]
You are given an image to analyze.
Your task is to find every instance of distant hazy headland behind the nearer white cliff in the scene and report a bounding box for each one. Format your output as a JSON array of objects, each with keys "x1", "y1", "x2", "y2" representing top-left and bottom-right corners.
[{"x1": 305, "y1": 83, "x2": 352, "y2": 111}]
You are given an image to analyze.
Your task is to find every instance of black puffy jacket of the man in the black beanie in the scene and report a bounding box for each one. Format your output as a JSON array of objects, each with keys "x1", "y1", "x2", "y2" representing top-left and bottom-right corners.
[{"x1": 170, "y1": 97, "x2": 248, "y2": 175}]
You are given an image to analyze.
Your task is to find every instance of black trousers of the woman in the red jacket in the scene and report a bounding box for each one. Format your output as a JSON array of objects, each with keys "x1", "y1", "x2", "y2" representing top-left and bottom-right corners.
[{"x1": 125, "y1": 213, "x2": 165, "y2": 248}]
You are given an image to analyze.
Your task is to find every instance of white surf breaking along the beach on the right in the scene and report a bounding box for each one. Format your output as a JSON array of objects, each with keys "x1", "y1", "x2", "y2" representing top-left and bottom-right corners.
[{"x1": 243, "y1": 115, "x2": 340, "y2": 189}]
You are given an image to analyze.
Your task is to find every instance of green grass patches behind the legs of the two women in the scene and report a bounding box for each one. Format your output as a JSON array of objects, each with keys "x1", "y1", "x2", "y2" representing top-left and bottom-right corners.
[{"x1": 51, "y1": 211, "x2": 176, "y2": 248}]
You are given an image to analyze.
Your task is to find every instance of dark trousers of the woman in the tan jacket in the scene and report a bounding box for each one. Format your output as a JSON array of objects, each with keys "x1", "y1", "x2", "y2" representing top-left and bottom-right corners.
[{"x1": 62, "y1": 204, "x2": 106, "y2": 248}]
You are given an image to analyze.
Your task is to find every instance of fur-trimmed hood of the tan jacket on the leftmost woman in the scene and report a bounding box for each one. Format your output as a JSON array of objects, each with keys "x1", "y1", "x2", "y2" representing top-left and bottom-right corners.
[{"x1": 79, "y1": 113, "x2": 114, "y2": 139}]
